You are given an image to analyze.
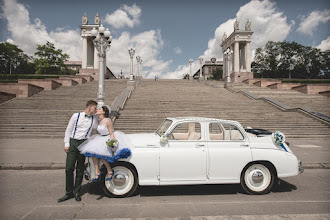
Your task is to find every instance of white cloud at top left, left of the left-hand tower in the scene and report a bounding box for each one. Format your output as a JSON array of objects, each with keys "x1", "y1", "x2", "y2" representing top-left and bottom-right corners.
[{"x1": 1, "y1": 0, "x2": 81, "y2": 60}]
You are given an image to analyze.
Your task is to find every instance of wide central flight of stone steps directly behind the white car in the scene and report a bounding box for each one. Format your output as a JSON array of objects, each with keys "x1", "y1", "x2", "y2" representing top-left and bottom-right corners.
[{"x1": 114, "y1": 79, "x2": 330, "y2": 139}]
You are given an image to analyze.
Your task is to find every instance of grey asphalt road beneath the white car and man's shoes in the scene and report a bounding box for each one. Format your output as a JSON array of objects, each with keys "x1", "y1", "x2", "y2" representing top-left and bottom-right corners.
[{"x1": 0, "y1": 169, "x2": 330, "y2": 220}]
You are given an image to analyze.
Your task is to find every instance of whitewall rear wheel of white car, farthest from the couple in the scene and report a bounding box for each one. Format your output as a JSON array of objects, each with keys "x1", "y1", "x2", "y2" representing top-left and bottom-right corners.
[{"x1": 241, "y1": 163, "x2": 275, "y2": 195}]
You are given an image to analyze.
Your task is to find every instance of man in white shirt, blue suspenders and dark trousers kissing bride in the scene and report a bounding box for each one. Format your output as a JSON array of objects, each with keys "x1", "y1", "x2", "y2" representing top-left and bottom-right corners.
[{"x1": 58, "y1": 100, "x2": 98, "y2": 202}]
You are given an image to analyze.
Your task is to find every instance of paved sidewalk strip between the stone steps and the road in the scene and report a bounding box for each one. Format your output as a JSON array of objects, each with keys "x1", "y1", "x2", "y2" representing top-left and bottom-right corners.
[{"x1": 0, "y1": 139, "x2": 330, "y2": 169}]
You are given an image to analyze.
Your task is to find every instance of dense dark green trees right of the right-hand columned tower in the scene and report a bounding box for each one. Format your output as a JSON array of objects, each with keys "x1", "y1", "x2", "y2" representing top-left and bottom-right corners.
[{"x1": 252, "y1": 41, "x2": 330, "y2": 79}]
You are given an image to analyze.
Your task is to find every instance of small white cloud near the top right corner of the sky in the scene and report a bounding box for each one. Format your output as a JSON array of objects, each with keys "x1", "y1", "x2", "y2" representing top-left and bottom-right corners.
[{"x1": 297, "y1": 9, "x2": 330, "y2": 36}]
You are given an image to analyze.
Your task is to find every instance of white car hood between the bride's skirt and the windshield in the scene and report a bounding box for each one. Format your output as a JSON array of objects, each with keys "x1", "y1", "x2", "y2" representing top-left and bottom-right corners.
[{"x1": 127, "y1": 133, "x2": 160, "y2": 147}]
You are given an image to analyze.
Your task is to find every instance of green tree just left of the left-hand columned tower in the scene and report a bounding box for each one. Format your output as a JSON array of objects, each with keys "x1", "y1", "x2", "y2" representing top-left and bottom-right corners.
[{"x1": 35, "y1": 41, "x2": 69, "y2": 74}]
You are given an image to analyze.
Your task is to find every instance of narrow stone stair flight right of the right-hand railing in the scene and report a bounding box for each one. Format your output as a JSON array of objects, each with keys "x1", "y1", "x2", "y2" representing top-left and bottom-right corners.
[{"x1": 227, "y1": 83, "x2": 330, "y2": 117}]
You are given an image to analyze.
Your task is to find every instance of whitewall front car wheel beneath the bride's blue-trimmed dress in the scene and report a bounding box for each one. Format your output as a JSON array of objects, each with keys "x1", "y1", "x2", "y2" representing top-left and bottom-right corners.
[{"x1": 101, "y1": 163, "x2": 138, "y2": 198}]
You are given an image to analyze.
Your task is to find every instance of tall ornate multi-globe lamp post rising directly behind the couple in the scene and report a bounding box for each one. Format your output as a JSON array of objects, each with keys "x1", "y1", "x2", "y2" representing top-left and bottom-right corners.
[{"x1": 91, "y1": 24, "x2": 112, "y2": 107}]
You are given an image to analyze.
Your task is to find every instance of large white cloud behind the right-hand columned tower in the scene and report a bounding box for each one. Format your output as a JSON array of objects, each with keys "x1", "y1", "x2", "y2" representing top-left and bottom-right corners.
[{"x1": 167, "y1": 0, "x2": 294, "y2": 78}]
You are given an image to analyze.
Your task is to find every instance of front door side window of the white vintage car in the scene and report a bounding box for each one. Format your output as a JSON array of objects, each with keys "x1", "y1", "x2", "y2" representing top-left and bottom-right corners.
[{"x1": 168, "y1": 122, "x2": 201, "y2": 141}]
